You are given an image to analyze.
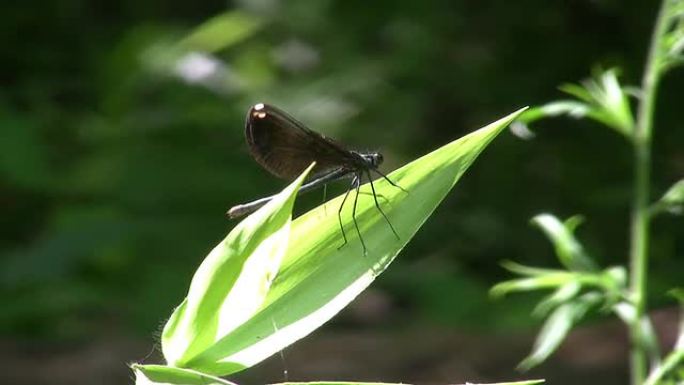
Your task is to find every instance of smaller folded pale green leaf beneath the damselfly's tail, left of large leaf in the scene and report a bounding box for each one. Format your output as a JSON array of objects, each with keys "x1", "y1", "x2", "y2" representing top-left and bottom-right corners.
[{"x1": 162, "y1": 166, "x2": 311, "y2": 368}]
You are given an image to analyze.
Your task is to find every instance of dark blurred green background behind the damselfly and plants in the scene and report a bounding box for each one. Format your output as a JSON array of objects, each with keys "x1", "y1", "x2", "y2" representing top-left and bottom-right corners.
[{"x1": 0, "y1": 0, "x2": 684, "y2": 384}]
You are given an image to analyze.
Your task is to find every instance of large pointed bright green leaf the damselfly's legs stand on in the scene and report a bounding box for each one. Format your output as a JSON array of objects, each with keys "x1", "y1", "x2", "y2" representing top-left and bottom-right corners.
[{"x1": 183, "y1": 110, "x2": 522, "y2": 375}]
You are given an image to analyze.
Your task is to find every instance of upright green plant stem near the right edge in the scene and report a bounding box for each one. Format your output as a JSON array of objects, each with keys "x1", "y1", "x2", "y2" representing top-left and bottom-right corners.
[{"x1": 629, "y1": 0, "x2": 670, "y2": 385}]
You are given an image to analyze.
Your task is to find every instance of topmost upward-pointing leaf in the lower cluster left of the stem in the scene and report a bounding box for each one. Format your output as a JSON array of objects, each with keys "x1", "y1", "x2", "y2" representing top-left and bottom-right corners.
[{"x1": 532, "y1": 214, "x2": 597, "y2": 271}]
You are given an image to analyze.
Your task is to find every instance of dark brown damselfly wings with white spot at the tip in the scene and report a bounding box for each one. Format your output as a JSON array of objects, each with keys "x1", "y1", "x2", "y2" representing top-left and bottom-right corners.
[{"x1": 245, "y1": 104, "x2": 353, "y2": 180}]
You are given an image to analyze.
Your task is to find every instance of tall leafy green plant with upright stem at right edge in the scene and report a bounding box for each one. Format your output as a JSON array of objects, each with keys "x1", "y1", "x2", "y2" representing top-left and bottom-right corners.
[{"x1": 492, "y1": 0, "x2": 684, "y2": 385}]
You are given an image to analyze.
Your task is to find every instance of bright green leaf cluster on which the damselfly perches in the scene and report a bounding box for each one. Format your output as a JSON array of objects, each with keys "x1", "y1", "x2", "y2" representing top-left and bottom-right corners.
[{"x1": 133, "y1": 106, "x2": 522, "y2": 384}]
